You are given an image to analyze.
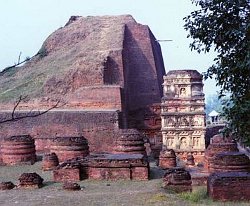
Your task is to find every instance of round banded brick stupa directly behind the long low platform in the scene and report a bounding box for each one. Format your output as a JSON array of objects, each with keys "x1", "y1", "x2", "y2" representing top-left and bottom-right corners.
[{"x1": 114, "y1": 129, "x2": 146, "y2": 155}]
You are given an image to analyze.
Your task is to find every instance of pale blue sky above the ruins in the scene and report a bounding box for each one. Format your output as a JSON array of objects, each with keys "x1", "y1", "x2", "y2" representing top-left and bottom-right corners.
[{"x1": 0, "y1": 0, "x2": 217, "y2": 96}]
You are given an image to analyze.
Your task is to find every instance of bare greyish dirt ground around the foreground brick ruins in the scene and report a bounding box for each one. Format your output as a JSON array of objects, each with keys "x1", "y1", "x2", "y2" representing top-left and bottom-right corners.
[{"x1": 0, "y1": 162, "x2": 250, "y2": 206}]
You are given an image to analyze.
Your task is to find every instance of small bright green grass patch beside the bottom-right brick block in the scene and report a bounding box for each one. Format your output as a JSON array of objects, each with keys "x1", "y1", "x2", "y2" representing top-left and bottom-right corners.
[{"x1": 180, "y1": 188, "x2": 208, "y2": 203}]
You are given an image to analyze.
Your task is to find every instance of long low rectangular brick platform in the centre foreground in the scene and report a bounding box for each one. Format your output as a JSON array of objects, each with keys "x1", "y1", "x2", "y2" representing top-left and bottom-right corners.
[{"x1": 54, "y1": 153, "x2": 149, "y2": 181}]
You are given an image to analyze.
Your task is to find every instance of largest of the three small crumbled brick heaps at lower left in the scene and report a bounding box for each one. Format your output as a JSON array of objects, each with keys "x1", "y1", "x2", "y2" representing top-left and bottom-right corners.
[{"x1": 18, "y1": 172, "x2": 43, "y2": 188}]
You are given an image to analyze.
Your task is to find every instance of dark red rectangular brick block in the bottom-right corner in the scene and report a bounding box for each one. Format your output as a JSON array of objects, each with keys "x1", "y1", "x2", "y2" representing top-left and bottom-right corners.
[{"x1": 207, "y1": 172, "x2": 250, "y2": 201}]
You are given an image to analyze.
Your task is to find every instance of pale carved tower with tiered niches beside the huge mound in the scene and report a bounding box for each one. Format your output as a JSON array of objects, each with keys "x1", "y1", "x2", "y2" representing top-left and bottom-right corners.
[{"x1": 161, "y1": 70, "x2": 205, "y2": 163}]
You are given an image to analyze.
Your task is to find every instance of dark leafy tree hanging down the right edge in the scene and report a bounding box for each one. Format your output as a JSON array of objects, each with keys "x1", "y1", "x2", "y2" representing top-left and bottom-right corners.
[{"x1": 184, "y1": 0, "x2": 250, "y2": 145}]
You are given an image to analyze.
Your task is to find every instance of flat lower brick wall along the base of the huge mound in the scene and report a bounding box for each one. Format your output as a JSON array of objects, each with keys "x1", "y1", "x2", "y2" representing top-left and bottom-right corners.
[{"x1": 0, "y1": 110, "x2": 120, "y2": 152}]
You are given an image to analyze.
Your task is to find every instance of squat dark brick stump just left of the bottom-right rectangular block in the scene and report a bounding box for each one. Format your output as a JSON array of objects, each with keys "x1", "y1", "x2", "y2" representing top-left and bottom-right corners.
[{"x1": 162, "y1": 168, "x2": 192, "y2": 192}]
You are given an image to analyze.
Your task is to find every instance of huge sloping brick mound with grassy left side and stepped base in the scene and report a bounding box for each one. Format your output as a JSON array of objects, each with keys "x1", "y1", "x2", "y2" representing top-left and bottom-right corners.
[{"x1": 0, "y1": 15, "x2": 165, "y2": 152}]
